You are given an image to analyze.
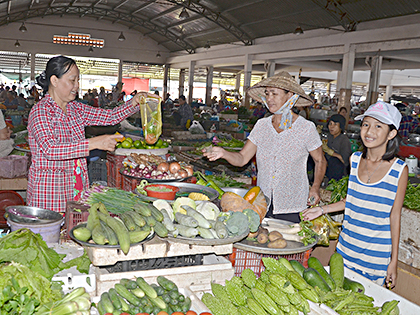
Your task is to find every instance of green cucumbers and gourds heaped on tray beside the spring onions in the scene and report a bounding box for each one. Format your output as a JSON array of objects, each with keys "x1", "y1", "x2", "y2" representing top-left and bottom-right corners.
[{"x1": 72, "y1": 202, "x2": 168, "y2": 254}]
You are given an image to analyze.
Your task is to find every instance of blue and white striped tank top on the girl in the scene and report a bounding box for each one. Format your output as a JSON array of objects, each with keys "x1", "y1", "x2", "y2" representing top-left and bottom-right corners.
[{"x1": 337, "y1": 152, "x2": 405, "y2": 285}]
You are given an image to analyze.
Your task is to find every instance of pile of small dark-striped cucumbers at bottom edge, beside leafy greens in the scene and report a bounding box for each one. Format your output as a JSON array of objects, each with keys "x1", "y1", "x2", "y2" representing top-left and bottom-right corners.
[{"x1": 96, "y1": 276, "x2": 191, "y2": 315}]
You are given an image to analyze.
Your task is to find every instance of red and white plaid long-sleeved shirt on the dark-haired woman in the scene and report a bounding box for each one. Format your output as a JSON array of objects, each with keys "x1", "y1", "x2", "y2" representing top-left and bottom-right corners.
[{"x1": 27, "y1": 94, "x2": 138, "y2": 212}]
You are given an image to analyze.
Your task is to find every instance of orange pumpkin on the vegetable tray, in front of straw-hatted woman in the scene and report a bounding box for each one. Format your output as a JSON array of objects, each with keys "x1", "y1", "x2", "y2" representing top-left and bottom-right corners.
[{"x1": 220, "y1": 191, "x2": 267, "y2": 222}]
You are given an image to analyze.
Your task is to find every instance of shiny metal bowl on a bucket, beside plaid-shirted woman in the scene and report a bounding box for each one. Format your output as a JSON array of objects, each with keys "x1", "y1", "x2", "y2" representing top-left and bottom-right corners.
[{"x1": 4, "y1": 206, "x2": 64, "y2": 224}]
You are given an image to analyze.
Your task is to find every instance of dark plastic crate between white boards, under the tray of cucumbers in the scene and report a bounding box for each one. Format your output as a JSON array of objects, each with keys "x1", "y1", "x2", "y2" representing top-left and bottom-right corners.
[{"x1": 100, "y1": 254, "x2": 203, "y2": 273}]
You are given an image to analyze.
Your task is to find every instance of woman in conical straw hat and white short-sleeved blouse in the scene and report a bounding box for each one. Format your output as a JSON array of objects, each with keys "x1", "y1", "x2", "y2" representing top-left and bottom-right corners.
[{"x1": 204, "y1": 71, "x2": 326, "y2": 222}]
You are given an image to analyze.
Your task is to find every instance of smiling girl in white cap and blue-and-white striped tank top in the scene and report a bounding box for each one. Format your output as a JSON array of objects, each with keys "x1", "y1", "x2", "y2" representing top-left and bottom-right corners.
[{"x1": 302, "y1": 101, "x2": 408, "y2": 287}]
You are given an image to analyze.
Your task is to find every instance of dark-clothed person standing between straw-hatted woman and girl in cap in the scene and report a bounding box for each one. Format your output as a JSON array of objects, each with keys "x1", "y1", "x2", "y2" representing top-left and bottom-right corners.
[{"x1": 322, "y1": 114, "x2": 351, "y2": 180}]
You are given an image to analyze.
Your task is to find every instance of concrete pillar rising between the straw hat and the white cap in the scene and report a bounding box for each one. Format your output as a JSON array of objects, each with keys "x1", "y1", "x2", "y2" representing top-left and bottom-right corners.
[{"x1": 337, "y1": 45, "x2": 356, "y2": 122}]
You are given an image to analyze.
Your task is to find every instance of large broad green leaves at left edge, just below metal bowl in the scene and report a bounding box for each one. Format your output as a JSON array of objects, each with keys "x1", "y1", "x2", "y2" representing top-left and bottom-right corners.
[{"x1": 0, "y1": 229, "x2": 90, "y2": 280}]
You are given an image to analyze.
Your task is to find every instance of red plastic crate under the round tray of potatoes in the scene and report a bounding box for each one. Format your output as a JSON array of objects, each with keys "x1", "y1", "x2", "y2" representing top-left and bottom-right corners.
[{"x1": 228, "y1": 248, "x2": 312, "y2": 277}]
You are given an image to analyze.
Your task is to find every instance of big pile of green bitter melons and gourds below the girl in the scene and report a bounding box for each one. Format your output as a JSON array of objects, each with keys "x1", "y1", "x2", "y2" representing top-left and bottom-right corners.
[{"x1": 202, "y1": 253, "x2": 398, "y2": 315}]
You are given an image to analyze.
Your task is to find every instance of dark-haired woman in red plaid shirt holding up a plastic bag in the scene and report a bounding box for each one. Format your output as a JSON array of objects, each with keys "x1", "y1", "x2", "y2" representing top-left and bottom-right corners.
[{"x1": 27, "y1": 56, "x2": 153, "y2": 212}]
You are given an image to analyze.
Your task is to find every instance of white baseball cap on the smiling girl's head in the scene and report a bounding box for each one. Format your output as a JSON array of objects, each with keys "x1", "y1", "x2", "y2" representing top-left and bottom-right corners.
[{"x1": 354, "y1": 101, "x2": 401, "y2": 130}]
